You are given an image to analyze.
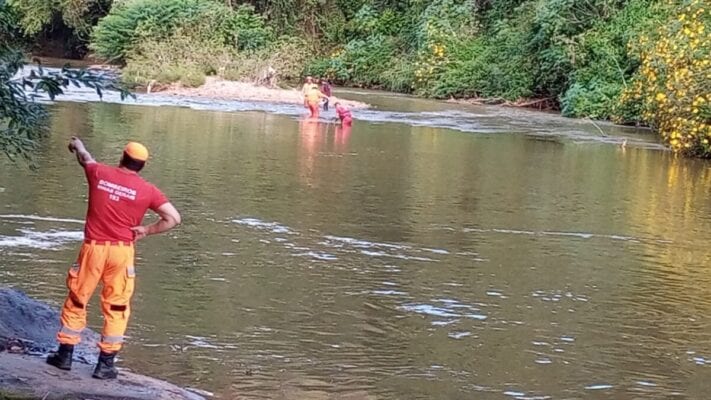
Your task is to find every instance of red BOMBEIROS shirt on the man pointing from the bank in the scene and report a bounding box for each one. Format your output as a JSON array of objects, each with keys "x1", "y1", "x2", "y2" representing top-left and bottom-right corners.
[{"x1": 84, "y1": 163, "x2": 168, "y2": 242}]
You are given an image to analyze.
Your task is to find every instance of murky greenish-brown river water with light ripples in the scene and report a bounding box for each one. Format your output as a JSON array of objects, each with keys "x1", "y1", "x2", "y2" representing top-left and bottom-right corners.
[{"x1": 0, "y1": 92, "x2": 711, "y2": 400}]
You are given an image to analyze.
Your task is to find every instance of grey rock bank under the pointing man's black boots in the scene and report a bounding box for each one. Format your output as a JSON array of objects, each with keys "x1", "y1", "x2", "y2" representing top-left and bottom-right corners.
[{"x1": 0, "y1": 288, "x2": 204, "y2": 400}]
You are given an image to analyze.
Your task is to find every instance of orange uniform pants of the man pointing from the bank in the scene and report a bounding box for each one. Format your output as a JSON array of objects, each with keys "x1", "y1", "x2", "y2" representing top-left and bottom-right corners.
[{"x1": 57, "y1": 241, "x2": 136, "y2": 353}]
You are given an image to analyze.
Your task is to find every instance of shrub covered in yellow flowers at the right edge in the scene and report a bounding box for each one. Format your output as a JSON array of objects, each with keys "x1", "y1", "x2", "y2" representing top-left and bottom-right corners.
[{"x1": 620, "y1": 0, "x2": 711, "y2": 157}]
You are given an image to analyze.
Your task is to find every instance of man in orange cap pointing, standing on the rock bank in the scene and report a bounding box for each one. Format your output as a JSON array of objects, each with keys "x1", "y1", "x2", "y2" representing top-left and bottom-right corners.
[{"x1": 47, "y1": 137, "x2": 180, "y2": 379}]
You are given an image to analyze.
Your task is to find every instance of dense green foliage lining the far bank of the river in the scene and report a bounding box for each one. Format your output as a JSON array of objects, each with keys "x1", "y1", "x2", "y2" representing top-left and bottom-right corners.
[{"x1": 1, "y1": 0, "x2": 711, "y2": 156}]
